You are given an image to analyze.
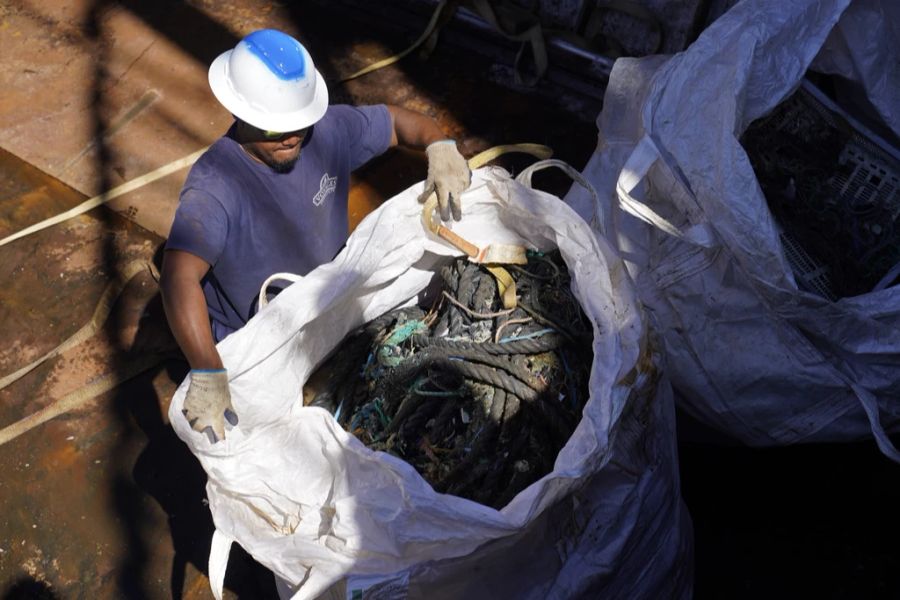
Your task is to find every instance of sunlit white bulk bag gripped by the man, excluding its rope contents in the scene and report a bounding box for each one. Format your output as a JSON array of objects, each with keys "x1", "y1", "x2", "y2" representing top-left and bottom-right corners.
[{"x1": 169, "y1": 168, "x2": 692, "y2": 600}]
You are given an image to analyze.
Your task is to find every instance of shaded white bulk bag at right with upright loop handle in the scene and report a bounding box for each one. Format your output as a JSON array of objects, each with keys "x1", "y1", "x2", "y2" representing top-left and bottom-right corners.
[{"x1": 566, "y1": 0, "x2": 900, "y2": 460}]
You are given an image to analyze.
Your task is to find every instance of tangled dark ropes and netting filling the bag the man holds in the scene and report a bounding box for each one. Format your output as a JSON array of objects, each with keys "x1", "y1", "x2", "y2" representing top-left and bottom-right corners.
[{"x1": 311, "y1": 251, "x2": 593, "y2": 508}]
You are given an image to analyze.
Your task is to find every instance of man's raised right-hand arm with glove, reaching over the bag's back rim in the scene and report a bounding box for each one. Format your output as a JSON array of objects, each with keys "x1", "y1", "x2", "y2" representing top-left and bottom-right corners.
[{"x1": 387, "y1": 105, "x2": 472, "y2": 221}]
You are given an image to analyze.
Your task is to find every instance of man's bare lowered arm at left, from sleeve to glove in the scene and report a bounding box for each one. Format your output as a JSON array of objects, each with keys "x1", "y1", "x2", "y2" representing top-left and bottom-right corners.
[{"x1": 159, "y1": 250, "x2": 223, "y2": 369}]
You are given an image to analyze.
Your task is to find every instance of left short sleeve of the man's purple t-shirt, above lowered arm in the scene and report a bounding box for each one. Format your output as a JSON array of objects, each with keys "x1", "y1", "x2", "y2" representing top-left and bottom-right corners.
[{"x1": 166, "y1": 189, "x2": 228, "y2": 265}]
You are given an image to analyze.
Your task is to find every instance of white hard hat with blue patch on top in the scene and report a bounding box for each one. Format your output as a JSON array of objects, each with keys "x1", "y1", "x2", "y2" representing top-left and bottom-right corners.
[{"x1": 209, "y1": 29, "x2": 328, "y2": 132}]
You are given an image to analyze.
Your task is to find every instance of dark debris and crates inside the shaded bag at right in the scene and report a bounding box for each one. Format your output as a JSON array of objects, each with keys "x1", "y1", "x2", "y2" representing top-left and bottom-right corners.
[{"x1": 741, "y1": 88, "x2": 900, "y2": 300}]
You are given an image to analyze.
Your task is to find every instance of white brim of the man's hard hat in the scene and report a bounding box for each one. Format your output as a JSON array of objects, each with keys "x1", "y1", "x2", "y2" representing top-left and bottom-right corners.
[{"x1": 209, "y1": 50, "x2": 328, "y2": 132}]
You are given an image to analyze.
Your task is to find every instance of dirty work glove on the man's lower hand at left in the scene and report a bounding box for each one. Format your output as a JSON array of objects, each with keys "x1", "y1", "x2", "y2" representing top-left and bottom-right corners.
[{"x1": 181, "y1": 369, "x2": 237, "y2": 444}]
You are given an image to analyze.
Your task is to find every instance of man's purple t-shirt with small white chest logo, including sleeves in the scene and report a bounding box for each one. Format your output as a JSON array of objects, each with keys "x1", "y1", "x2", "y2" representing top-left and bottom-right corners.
[{"x1": 166, "y1": 105, "x2": 391, "y2": 341}]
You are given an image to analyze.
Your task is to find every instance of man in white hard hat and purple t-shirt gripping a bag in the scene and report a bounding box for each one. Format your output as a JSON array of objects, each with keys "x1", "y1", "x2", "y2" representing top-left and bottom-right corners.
[{"x1": 160, "y1": 29, "x2": 471, "y2": 442}]
